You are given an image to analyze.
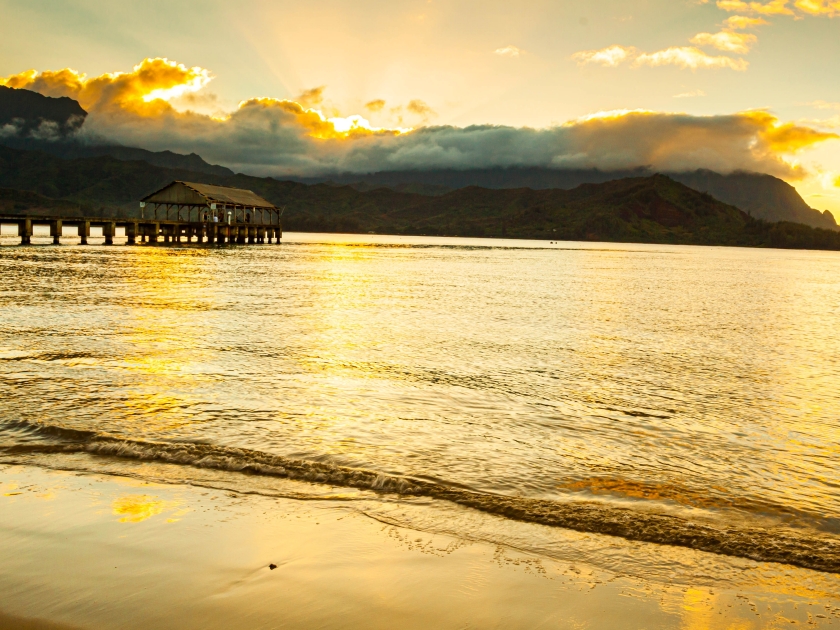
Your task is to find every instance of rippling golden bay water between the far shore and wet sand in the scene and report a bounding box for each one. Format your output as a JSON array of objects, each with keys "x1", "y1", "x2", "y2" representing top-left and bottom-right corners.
[{"x1": 0, "y1": 234, "x2": 840, "y2": 586}]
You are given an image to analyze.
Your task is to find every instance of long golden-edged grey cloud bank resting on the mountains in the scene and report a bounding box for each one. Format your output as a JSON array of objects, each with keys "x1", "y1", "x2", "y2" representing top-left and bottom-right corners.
[{"x1": 0, "y1": 59, "x2": 838, "y2": 180}]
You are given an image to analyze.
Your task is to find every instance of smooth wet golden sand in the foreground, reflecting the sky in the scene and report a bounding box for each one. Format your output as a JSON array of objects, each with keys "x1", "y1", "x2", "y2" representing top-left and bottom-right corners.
[{"x1": 0, "y1": 465, "x2": 840, "y2": 629}]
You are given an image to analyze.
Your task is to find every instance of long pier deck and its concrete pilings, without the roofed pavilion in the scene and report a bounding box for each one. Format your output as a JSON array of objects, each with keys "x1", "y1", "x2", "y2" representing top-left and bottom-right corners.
[{"x1": 0, "y1": 214, "x2": 283, "y2": 245}]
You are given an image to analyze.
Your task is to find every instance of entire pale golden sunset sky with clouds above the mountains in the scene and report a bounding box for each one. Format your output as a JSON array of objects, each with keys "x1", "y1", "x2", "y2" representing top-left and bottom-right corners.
[{"x1": 0, "y1": 0, "x2": 840, "y2": 218}]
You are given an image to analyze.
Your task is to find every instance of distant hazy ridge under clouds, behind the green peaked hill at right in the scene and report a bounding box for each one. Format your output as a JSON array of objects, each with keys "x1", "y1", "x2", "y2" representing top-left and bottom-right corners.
[{"x1": 296, "y1": 167, "x2": 838, "y2": 230}]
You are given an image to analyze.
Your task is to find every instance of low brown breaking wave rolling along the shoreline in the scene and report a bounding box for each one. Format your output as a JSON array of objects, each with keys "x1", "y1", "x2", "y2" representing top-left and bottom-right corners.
[{"x1": 0, "y1": 422, "x2": 840, "y2": 574}]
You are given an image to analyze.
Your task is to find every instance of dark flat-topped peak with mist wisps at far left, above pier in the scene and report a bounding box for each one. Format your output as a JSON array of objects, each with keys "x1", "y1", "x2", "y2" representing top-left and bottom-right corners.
[{"x1": 0, "y1": 85, "x2": 87, "y2": 139}]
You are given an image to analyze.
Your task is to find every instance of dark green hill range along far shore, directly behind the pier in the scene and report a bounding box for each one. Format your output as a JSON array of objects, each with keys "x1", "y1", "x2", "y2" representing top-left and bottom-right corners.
[{"x1": 0, "y1": 147, "x2": 840, "y2": 250}]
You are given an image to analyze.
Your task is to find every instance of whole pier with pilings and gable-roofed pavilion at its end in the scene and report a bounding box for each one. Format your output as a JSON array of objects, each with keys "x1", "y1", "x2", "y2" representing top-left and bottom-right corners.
[{"x1": 0, "y1": 182, "x2": 283, "y2": 245}]
